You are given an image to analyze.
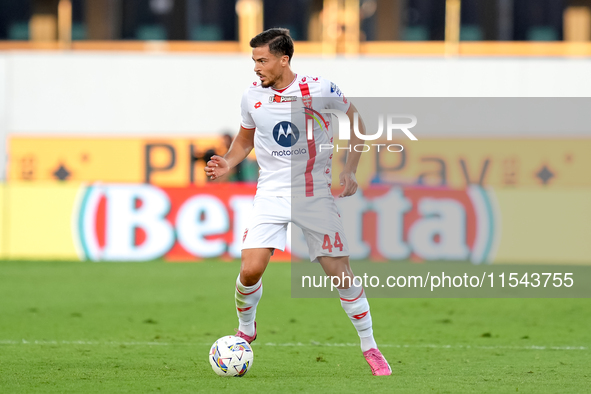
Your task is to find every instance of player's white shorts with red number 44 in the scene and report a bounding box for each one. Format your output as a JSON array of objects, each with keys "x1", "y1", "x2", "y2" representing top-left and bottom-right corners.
[{"x1": 242, "y1": 195, "x2": 349, "y2": 262}]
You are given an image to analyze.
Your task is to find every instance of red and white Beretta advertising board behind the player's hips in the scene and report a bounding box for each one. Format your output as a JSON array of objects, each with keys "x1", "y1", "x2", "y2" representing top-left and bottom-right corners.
[{"x1": 74, "y1": 183, "x2": 498, "y2": 264}]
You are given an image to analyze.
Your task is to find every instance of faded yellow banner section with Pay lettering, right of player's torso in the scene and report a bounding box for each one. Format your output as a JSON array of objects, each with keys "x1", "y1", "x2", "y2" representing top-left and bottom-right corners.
[{"x1": 333, "y1": 139, "x2": 591, "y2": 188}]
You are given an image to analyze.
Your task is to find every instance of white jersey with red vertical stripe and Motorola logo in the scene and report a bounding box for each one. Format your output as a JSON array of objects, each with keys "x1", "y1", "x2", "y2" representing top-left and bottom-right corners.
[{"x1": 241, "y1": 75, "x2": 349, "y2": 197}]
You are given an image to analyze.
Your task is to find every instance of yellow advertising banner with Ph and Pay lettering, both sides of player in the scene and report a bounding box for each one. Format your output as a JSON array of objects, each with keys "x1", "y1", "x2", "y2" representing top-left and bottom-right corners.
[{"x1": 8, "y1": 136, "x2": 591, "y2": 188}]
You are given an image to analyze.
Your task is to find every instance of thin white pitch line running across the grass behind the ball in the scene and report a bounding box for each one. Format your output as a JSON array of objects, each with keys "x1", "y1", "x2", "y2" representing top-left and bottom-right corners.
[{"x1": 0, "y1": 339, "x2": 589, "y2": 350}]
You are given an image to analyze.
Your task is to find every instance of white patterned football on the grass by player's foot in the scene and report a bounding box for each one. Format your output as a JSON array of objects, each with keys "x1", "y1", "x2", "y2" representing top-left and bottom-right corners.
[{"x1": 209, "y1": 335, "x2": 253, "y2": 378}]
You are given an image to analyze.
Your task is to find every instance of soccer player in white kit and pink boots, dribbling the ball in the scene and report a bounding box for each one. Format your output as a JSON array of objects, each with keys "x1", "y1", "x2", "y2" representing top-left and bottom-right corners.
[{"x1": 205, "y1": 28, "x2": 392, "y2": 375}]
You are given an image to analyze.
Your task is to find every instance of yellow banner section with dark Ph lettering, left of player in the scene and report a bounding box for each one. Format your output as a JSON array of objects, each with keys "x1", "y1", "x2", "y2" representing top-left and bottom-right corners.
[{"x1": 8, "y1": 136, "x2": 226, "y2": 186}]
